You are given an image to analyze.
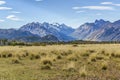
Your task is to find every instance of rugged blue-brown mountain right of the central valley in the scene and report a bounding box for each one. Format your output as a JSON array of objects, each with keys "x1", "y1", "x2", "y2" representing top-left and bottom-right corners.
[{"x1": 72, "y1": 19, "x2": 120, "y2": 41}]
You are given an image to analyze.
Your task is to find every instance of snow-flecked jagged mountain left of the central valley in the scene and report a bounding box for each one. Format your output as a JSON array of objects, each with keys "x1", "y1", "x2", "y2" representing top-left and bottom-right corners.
[{"x1": 19, "y1": 22, "x2": 74, "y2": 41}]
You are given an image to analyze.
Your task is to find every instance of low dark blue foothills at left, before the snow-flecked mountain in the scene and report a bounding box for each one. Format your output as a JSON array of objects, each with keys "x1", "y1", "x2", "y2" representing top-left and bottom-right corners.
[{"x1": 0, "y1": 29, "x2": 59, "y2": 42}]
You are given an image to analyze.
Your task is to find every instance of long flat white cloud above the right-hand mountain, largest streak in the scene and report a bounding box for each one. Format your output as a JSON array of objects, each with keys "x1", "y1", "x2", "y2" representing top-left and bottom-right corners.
[{"x1": 80, "y1": 6, "x2": 114, "y2": 10}]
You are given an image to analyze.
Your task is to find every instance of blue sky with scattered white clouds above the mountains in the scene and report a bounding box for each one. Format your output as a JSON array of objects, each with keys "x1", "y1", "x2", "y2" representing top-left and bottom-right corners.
[{"x1": 0, "y1": 0, "x2": 120, "y2": 29}]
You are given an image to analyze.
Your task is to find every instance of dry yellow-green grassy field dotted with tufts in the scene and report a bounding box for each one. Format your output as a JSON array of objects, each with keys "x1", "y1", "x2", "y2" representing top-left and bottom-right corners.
[{"x1": 0, "y1": 44, "x2": 120, "y2": 80}]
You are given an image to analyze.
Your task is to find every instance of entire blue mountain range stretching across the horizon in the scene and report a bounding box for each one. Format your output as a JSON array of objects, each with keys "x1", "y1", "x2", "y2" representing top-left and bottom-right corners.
[{"x1": 0, "y1": 19, "x2": 120, "y2": 42}]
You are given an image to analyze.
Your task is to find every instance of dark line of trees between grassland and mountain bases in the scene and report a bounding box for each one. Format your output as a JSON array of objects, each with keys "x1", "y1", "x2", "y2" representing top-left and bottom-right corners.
[{"x1": 0, "y1": 39, "x2": 120, "y2": 46}]
